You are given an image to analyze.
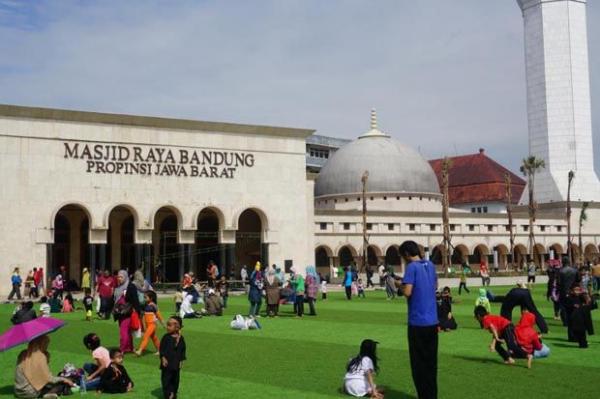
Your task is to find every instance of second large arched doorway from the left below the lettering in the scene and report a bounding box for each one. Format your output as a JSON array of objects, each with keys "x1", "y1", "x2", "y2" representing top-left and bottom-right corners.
[{"x1": 106, "y1": 206, "x2": 140, "y2": 273}]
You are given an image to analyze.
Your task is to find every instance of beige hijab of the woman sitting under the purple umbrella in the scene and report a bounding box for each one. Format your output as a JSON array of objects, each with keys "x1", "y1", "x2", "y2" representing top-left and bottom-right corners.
[{"x1": 18, "y1": 335, "x2": 52, "y2": 392}]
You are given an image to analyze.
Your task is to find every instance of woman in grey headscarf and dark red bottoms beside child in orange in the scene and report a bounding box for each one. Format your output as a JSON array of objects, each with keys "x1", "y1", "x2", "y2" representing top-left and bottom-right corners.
[{"x1": 113, "y1": 270, "x2": 141, "y2": 353}]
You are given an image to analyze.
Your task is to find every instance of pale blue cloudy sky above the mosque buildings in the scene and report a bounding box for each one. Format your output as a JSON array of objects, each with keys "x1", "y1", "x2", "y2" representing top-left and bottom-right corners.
[{"x1": 0, "y1": 0, "x2": 600, "y2": 170}]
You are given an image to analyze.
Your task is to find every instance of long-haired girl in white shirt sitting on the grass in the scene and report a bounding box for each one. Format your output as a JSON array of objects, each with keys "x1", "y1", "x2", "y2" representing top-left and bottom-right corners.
[{"x1": 344, "y1": 339, "x2": 383, "y2": 399}]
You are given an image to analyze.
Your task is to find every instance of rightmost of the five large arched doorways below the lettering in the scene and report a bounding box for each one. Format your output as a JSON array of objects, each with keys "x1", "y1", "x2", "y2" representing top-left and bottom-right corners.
[{"x1": 235, "y1": 209, "x2": 266, "y2": 270}]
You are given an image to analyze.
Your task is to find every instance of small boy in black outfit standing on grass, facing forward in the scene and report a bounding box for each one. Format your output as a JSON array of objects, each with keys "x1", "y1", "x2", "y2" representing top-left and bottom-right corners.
[{"x1": 160, "y1": 316, "x2": 186, "y2": 399}]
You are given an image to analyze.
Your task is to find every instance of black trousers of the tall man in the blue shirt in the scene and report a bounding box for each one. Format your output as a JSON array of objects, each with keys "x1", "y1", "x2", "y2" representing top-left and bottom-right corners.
[{"x1": 408, "y1": 325, "x2": 439, "y2": 399}]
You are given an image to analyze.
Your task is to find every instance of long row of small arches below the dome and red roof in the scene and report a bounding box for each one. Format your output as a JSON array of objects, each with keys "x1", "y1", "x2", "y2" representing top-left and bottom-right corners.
[{"x1": 315, "y1": 243, "x2": 600, "y2": 269}]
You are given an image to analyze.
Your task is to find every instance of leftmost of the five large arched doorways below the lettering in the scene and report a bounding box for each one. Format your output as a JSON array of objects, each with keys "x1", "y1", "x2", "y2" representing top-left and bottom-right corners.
[{"x1": 47, "y1": 204, "x2": 90, "y2": 286}]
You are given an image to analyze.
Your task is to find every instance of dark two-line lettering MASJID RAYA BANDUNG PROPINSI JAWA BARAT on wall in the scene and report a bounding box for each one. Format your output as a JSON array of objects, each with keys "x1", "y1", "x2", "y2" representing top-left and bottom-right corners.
[{"x1": 63, "y1": 142, "x2": 254, "y2": 179}]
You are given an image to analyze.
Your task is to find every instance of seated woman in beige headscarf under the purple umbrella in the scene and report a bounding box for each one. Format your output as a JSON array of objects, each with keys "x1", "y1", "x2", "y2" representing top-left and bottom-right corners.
[{"x1": 15, "y1": 335, "x2": 74, "y2": 398}]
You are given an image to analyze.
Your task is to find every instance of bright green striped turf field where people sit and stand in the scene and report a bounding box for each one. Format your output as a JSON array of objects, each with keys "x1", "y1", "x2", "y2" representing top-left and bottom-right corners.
[{"x1": 0, "y1": 285, "x2": 600, "y2": 399}]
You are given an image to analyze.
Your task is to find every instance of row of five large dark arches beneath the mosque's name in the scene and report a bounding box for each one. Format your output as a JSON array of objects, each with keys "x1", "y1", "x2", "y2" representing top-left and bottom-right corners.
[{"x1": 52, "y1": 203, "x2": 268, "y2": 282}]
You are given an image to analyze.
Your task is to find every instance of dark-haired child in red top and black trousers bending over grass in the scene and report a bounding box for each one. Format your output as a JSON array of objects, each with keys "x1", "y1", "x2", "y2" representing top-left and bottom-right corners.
[{"x1": 475, "y1": 306, "x2": 527, "y2": 364}]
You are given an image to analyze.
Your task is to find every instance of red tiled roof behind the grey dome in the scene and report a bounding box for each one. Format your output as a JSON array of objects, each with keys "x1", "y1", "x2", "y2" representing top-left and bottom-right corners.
[{"x1": 429, "y1": 150, "x2": 525, "y2": 205}]
